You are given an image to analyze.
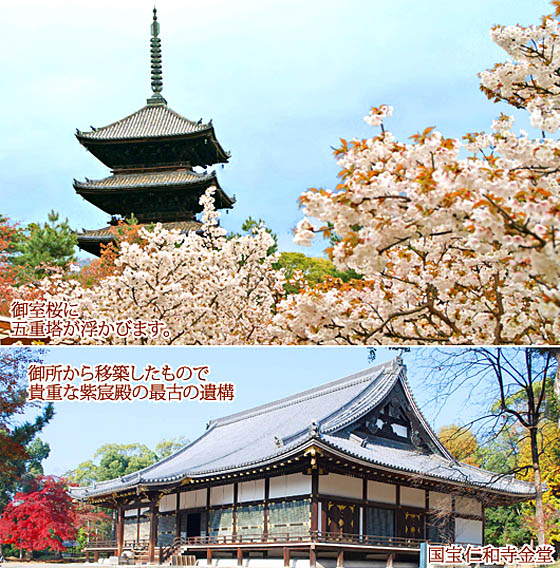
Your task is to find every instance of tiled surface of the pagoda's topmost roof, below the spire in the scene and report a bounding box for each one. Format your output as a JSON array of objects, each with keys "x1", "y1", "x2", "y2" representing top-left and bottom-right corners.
[{"x1": 78, "y1": 105, "x2": 212, "y2": 140}]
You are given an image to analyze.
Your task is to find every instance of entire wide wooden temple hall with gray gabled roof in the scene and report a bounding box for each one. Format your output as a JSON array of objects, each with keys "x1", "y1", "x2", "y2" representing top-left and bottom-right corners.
[{"x1": 71, "y1": 358, "x2": 534, "y2": 568}]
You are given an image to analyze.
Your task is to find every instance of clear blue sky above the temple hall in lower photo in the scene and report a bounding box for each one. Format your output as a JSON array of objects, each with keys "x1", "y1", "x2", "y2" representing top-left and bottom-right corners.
[{"x1": 10, "y1": 347, "x2": 476, "y2": 475}]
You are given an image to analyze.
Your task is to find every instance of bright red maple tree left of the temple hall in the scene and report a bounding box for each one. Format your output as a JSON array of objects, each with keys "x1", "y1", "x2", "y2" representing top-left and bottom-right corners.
[{"x1": 0, "y1": 476, "x2": 79, "y2": 551}]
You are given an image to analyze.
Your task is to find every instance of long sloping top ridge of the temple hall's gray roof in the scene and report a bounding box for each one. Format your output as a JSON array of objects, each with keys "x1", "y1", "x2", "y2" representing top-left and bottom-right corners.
[{"x1": 209, "y1": 360, "x2": 393, "y2": 427}]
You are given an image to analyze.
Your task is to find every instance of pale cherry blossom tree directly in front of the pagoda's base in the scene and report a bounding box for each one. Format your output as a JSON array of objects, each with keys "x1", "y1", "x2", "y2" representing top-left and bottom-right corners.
[{"x1": 43, "y1": 188, "x2": 284, "y2": 345}]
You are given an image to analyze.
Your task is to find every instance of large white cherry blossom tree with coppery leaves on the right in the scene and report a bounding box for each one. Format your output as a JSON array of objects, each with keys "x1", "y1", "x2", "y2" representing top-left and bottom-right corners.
[{"x1": 275, "y1": 5, "x2": 560, "y2": 344}]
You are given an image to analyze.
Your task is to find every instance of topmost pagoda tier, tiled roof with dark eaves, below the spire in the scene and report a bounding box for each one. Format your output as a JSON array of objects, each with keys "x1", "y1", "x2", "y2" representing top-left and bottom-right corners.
[{"x1": 76, "y1": 104, "x2": 229, "y2": 172}]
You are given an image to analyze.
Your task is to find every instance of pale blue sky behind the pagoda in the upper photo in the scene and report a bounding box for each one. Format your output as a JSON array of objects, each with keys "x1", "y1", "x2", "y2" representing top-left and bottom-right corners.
[{"x1": 0, "y1": 0, "x2": 550, "y2": 253}]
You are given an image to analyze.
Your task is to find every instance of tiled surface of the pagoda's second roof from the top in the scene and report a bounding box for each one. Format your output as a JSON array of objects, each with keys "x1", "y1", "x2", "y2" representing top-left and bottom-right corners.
[{"x1": 74, "y1": 170, "x2": 218, "y2": 190}]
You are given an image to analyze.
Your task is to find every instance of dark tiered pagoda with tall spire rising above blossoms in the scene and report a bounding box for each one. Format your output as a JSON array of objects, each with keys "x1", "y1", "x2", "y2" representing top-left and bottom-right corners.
[{"x1": 74, "y1": 8, "x2": 235, "y2": 255}]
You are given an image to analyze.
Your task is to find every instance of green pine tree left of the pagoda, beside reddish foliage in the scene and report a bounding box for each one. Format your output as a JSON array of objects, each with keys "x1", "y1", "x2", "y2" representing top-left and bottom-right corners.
[{"x1": 10, "y1": 211, "x2": 78, "y2": 281}]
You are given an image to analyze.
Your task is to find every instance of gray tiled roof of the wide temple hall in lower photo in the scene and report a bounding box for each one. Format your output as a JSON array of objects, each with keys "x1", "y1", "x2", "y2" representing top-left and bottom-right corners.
[{"x1": 73, "y1": 359, "x2": 532, "y2": 497}]
